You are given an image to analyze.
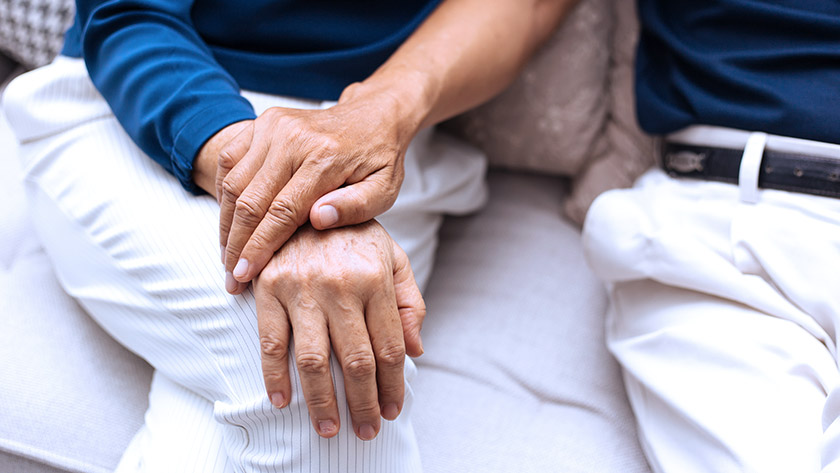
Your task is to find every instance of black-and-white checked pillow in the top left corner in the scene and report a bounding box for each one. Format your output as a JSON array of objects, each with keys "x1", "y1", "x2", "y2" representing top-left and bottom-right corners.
[{"x1": 0, "y1": 0, "x2": 75, "y2": 69}]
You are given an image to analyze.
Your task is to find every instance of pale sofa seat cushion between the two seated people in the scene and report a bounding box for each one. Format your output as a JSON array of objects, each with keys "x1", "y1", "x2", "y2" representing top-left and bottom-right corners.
[{"x1": 414, "y1": 172, "x2": 650, "y2": 473}]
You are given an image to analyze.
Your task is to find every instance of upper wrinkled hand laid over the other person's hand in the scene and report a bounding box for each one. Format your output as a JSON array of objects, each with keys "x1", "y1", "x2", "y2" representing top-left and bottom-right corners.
[{"x1": 216, "y1": 86, "x2": 418, "y2": 293}]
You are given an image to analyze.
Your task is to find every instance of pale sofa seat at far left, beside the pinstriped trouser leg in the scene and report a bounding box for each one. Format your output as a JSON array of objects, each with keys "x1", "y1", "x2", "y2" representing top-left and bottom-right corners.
[{"x1": 0, "y1": 101, "x2": 151, "y2": 472}]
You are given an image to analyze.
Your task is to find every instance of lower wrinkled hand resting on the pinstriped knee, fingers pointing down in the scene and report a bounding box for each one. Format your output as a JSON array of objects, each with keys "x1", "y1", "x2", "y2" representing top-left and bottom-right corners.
[{"x1": 254, "y1": 221, "x2": 425, "y2": 440}]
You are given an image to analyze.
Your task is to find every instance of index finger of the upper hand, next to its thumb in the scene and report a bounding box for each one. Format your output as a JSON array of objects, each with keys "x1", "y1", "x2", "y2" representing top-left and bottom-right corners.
[{"x1": 227, "y1": 163, "x2": 344, "y2": 282}]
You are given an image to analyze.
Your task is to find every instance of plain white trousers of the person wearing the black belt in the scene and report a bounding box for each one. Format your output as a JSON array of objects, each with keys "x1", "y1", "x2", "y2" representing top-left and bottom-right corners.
[{"x1": 584, "y1": 130, "x2": 840, "y2": 473}]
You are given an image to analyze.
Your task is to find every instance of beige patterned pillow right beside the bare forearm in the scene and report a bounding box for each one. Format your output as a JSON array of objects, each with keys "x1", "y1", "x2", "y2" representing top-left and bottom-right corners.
[{"x1": 443, "y1": 0, "x2": 612, "y2": 176}]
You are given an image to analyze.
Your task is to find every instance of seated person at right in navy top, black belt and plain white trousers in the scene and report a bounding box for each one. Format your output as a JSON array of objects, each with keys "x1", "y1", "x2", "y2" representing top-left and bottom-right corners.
[{"x1": 584, "y1": 0, "x2": 840, "y2": 473}]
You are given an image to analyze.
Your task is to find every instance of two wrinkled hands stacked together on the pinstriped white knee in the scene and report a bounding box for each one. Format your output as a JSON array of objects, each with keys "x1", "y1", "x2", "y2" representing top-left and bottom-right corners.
[{"x1": 194, "y1": 86, "x2": 425, "y2": 440}]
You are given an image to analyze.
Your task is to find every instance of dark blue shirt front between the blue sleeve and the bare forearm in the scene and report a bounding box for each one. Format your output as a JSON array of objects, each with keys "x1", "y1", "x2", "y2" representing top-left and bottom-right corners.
[{"x1": 63, "y1": 0, "x2": 440, "y2": 100}]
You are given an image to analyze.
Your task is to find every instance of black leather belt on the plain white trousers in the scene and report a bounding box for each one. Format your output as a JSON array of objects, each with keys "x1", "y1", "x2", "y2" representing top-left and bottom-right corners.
[{"x1": 662, "y1": 142, "x2": 840, "y2": 198}]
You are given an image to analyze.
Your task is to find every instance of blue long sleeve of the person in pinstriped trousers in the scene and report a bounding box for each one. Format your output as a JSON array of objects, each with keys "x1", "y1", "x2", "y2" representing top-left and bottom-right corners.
[{"x1": 77, "y1": 0, "x2": 255, "y2": 193}]
